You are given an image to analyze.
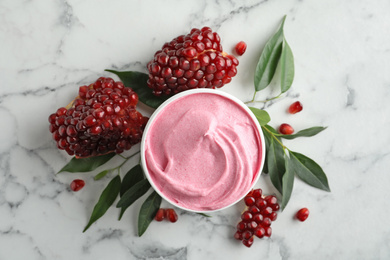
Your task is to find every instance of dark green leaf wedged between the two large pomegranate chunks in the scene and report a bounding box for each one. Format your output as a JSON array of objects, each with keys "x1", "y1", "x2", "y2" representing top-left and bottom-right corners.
[{"x1": 106, "y1": 70, "x2": 170, "y2": 108}]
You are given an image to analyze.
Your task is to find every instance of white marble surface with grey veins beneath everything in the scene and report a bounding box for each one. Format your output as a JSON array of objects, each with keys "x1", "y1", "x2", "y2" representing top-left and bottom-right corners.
[{"x1": 0, "y1": 0, "x2": 390, "y2": 260}]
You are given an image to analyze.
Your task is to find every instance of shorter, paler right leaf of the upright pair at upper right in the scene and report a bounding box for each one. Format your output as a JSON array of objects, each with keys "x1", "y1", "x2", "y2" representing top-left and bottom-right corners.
[{"x1": 280, "y1": 38, "x2": 294, "y2": 93}]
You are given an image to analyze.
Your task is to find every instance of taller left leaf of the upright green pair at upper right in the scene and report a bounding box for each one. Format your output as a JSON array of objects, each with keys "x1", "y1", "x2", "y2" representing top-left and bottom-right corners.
[{"x1": 255, "y1": 16, "x2": 286, "y2": 91}]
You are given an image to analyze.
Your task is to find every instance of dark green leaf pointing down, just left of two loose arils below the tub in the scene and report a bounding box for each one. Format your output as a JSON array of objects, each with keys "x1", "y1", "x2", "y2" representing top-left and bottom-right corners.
[{"x1": 138, "y1": 191, "x2": 162, "y2": 236}]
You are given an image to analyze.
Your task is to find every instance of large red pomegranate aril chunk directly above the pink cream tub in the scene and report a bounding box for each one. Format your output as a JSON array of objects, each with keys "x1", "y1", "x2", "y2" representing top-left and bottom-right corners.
[{"x1": 147, "y1": 27, "x2": 238, "y2": 96}]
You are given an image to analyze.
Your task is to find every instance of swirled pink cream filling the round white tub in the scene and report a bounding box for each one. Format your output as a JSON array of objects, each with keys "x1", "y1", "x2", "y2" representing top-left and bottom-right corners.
[{"x1": 144, "y1": 93, "x2": 262, "y2": 211}]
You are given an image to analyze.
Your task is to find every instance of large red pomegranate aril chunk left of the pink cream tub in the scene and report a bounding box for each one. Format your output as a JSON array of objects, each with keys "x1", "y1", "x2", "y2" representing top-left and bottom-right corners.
[{"x1": 49, "y1": 77, "x2": 148, "y2": 158}]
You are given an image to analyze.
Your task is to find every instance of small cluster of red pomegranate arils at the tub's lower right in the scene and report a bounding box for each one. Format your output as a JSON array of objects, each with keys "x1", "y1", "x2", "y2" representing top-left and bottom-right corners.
[{"x1": 234, "y1": 189, "x2": 280, "y2": 247}]
